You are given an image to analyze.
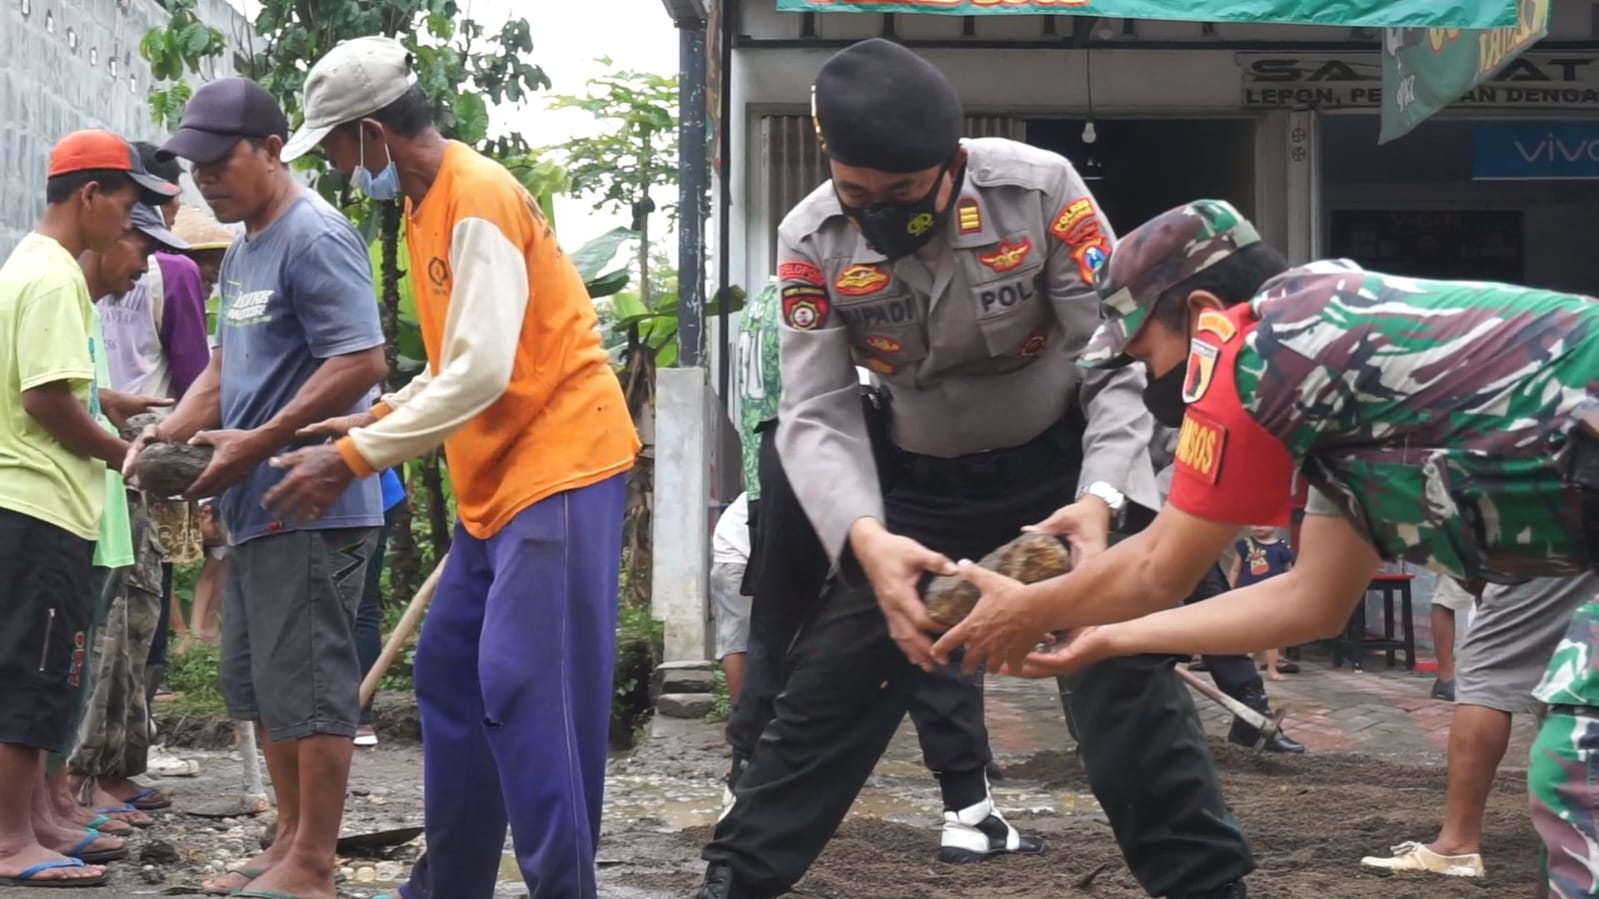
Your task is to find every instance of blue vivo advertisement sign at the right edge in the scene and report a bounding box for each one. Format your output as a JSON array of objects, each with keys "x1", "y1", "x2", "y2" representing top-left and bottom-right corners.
[{"x1": 1471, "y1": 122, "x2": 1599, "y2": 181}]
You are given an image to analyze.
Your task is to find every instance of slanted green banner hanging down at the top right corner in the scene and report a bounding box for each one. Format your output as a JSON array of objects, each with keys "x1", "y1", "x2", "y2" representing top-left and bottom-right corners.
[{"x1": 1377, "y1": 0, "x2": 1549, "y2": 144}]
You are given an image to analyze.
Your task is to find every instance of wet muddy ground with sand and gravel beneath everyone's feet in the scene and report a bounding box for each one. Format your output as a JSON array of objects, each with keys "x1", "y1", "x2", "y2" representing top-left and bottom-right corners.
[{"x1": 6, "y1": 707, "x2": 1540, "y2": 899}]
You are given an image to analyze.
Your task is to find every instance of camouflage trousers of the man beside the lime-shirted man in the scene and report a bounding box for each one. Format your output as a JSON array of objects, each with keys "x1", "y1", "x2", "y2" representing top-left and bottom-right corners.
[{"x1": 67, "y1": 493, "x2": 163, "y2": 777}]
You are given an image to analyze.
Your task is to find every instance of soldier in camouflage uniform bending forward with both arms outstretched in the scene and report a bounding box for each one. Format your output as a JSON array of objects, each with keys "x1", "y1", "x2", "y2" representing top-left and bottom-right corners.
[{"x1": 934, "y1": 200, "x2": 1599, "y2": 897}]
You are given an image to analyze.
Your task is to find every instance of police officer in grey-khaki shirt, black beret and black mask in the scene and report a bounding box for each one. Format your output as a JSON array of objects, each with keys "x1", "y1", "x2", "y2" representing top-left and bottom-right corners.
[{"x1": 699, "y1": 40, "x2": 1254, "y2": 899}]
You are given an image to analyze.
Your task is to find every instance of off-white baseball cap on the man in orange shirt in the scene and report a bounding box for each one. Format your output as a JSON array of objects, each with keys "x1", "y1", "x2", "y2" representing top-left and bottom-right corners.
[{"x1": 283, "y1": 35, "x2": 416, "y2": 162}]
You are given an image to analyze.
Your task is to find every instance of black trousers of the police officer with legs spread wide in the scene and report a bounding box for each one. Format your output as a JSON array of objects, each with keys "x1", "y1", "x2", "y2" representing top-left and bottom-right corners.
[{"x1": 702, "y1": 415, "x2": 1255, "y2": 899}]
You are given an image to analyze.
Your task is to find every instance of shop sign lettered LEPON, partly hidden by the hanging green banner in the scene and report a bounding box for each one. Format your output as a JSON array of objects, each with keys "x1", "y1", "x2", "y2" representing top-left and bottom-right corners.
[{"x1": 1238, "y1": 53, "x2": 1599, "y2": 110}]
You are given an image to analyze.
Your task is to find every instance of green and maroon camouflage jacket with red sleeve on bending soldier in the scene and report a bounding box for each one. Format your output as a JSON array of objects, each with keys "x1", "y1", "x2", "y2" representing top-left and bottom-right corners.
[{"x1": 1172, "y1": 261, "x2": 1599, "y2": 705}]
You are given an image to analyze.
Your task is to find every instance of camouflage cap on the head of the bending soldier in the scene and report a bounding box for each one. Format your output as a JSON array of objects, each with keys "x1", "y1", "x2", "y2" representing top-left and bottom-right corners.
[{"x1": 1078, "y1": 200, "x2": 1260, "y2": 368}]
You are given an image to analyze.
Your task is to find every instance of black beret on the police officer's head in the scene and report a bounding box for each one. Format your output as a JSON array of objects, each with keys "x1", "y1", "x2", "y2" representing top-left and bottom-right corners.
[{"x1": 811, "y1": 38, "x2": 963, "y2": 174}]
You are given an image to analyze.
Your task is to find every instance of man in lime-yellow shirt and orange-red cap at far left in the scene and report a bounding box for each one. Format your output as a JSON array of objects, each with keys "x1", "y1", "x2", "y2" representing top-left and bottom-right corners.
[{"x1": 0, "y1": 131, "x2": 177, "y2": 886}]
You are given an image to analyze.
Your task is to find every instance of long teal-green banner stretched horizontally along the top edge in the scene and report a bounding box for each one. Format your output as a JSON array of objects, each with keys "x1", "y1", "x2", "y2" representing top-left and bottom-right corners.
[{"x1": 777, "y1": 0, "x2": 1517, "y2": 29}]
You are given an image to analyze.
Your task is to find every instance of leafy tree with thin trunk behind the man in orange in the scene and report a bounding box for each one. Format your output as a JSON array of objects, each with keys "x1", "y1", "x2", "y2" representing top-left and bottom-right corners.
[{"x1": 139, "y1": 0, "x2": 568, "y2": 595}]
